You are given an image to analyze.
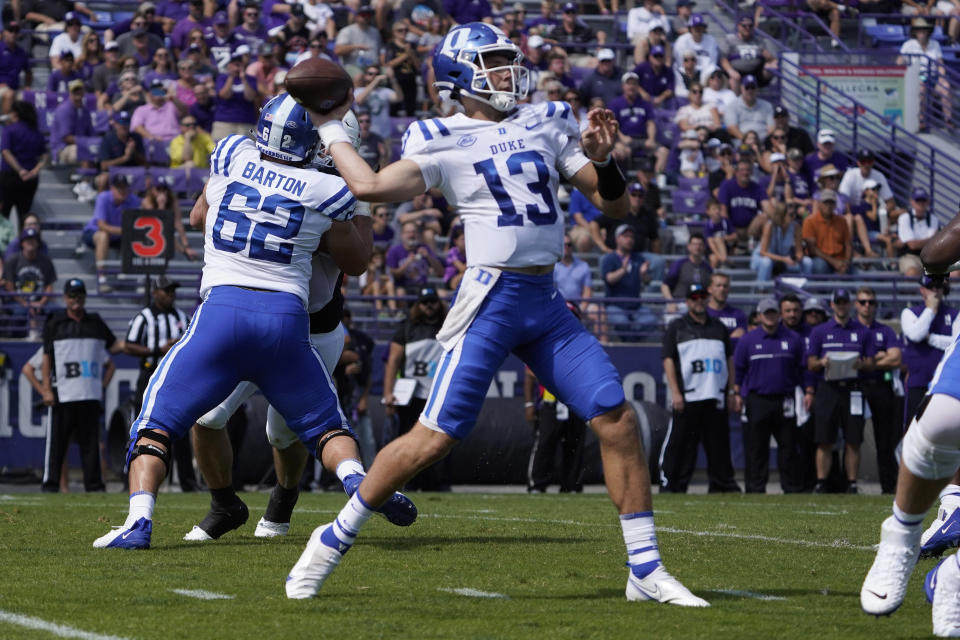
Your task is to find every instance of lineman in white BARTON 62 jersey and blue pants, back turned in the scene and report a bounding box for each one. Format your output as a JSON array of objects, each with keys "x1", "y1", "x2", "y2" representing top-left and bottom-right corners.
[{"x1": 93, "y1": 94, "x2": 376, "y2": 549}]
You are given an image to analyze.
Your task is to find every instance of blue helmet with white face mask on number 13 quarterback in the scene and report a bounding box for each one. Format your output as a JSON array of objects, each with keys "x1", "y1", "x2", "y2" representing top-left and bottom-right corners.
[{"x1": 433, "y1": 22, "x2": 530, "y2": 111}]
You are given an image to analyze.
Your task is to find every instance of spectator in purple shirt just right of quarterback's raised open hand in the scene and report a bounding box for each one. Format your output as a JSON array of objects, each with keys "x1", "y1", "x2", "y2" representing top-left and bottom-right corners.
[{"x1": 607, "y1": 71, "x2": 670, "y2": 173}]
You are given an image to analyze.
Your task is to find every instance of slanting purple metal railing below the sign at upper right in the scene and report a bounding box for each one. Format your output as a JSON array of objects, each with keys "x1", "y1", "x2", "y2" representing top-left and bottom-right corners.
[{"x1": 774, "y1": 56, "x2": 960, "y2": 222}]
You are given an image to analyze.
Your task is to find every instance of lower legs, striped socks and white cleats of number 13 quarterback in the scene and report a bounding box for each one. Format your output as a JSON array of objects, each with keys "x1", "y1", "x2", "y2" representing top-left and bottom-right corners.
[{"x1": 286, "y1": 403, "x2": 710, "y2": 607}]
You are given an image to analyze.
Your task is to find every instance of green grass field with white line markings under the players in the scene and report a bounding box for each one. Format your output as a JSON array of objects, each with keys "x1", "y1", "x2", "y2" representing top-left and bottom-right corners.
[{"x1": 0, "y1": 493, "x2": 934, "y2": 640}]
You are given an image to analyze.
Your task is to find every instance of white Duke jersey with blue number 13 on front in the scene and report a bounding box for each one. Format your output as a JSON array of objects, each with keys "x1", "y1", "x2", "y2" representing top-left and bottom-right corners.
[{"x1": 403, "y1": 102, "x2": 589, "y2": 267}]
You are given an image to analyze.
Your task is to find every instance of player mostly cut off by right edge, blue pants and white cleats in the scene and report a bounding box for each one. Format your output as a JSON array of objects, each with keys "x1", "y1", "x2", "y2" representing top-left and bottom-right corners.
[{"x1": 864, "y1": 209, "x2": 960, "y2": 637}]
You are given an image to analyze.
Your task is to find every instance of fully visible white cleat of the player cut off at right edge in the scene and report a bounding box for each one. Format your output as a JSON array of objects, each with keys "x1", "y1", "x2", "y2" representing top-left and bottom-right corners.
[{"x1": 860, "y1": 516, "x2": 921, "y2": 616}]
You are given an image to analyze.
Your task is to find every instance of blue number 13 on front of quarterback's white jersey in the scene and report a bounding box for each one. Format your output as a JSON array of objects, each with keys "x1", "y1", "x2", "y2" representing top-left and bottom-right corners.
[{"x1": 473, "y1": 150, "x2": 557, "y2": 227}]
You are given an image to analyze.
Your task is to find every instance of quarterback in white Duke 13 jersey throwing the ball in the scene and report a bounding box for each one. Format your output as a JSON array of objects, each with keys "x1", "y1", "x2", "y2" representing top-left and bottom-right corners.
[{"x1": 286, "y1": 22, "x2": 709, "y2": 607}]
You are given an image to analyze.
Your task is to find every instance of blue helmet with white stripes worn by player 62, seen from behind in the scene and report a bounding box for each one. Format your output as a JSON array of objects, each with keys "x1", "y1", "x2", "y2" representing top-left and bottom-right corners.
[{"x1": 257, "y1": 93, "x2": 320, "y2": 162}]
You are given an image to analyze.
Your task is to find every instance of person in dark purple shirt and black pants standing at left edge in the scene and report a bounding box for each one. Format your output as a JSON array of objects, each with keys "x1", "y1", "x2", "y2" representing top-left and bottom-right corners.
[{"x1": 0, "y1": 100, "x2": 47, "y2": 229}]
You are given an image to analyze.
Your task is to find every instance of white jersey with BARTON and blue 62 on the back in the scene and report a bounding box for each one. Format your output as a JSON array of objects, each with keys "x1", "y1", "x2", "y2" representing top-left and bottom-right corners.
[{"x1": 200, "y1": 135, "x2": 356, "y2": 305}]
